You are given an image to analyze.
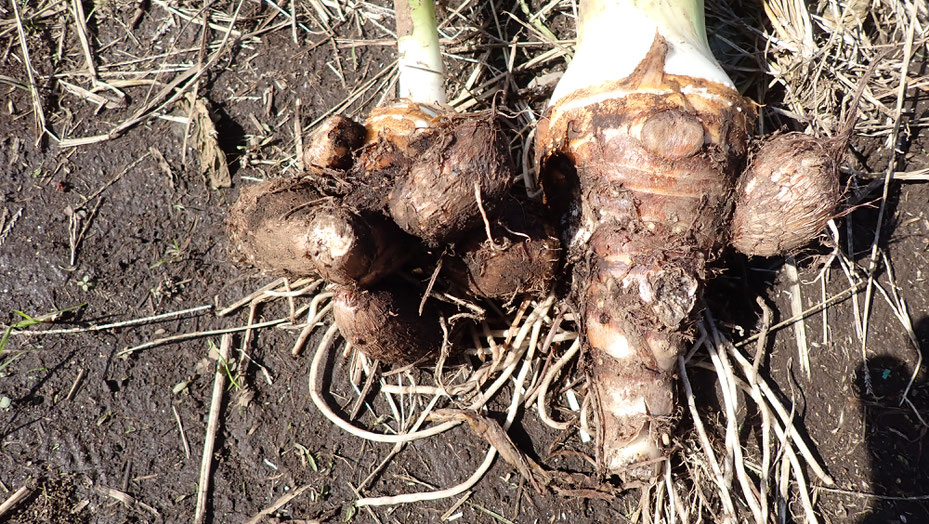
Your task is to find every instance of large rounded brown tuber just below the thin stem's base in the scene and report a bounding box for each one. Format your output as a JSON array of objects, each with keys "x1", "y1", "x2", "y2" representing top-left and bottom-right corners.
[{"x1": 387, "y1": 113, "x2": 515, "y2": 247}]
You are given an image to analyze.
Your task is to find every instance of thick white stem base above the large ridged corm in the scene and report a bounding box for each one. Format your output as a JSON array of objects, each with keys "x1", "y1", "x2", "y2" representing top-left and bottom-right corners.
[{"x1": 550, "y1": 0, "x2": 734, "y2": 105}]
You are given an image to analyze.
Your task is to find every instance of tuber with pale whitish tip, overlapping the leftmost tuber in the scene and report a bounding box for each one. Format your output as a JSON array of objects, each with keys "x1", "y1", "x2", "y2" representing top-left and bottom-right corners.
[{"x1": 307, "y1": 204, "x2": 410, "y2": 287}]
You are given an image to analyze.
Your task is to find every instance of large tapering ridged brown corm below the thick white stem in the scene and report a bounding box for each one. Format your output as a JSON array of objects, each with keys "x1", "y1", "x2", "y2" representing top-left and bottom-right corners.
[{"x1": 536, "y1": 35, "x2": 754, "y2": 485}]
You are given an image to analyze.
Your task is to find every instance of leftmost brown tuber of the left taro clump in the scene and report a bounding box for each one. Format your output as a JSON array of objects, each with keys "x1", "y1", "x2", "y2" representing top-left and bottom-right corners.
[{"x1": 226, "y1": 178, "x2": 321, "y2": 276}]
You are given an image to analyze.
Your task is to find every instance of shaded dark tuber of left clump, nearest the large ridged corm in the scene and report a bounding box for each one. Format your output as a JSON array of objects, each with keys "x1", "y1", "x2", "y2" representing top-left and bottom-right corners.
[{"x1": 445, "y1": 199, "x2": 561, "y2": 300}]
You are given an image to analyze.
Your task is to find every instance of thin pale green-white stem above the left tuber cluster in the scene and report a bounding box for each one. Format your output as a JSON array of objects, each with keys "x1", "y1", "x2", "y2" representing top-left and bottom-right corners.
[{"x1": 394, "y1": 0, "x2": 446, "y2": 105}]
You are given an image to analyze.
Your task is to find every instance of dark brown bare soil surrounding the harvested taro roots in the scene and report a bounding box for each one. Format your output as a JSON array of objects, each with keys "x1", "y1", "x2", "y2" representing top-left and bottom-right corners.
[{"x1": 0, "y1": 1, "x2": 929, "y2": 523}]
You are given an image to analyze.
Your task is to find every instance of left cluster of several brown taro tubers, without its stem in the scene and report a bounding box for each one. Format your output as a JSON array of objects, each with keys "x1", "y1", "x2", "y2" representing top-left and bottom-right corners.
[{"x1": 228, "y1": 110, "x2": 544, "y2": 364}]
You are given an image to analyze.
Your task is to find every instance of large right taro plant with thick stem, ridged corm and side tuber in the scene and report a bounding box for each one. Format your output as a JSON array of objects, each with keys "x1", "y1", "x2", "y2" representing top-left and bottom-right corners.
[{"x1": 524, "y1": 0, "x2": 873, "y2": 486}]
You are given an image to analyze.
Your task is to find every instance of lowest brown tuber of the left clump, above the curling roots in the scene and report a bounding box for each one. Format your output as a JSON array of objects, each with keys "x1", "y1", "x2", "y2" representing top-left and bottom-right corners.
[{"x1": 332, "y1": 284, "x2": 442, "y2": 365}]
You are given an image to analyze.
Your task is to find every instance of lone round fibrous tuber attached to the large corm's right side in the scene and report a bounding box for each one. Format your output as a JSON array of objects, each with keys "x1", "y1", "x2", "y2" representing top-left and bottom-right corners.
[{"x1": 731, "y1": 133, "x2": 841, "y2": 256}]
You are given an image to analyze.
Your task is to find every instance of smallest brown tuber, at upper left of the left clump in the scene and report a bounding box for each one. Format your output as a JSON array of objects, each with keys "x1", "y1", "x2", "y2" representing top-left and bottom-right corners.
[{"x1": 303, "y1": 115, "x2": 366, "y2": 171}]
